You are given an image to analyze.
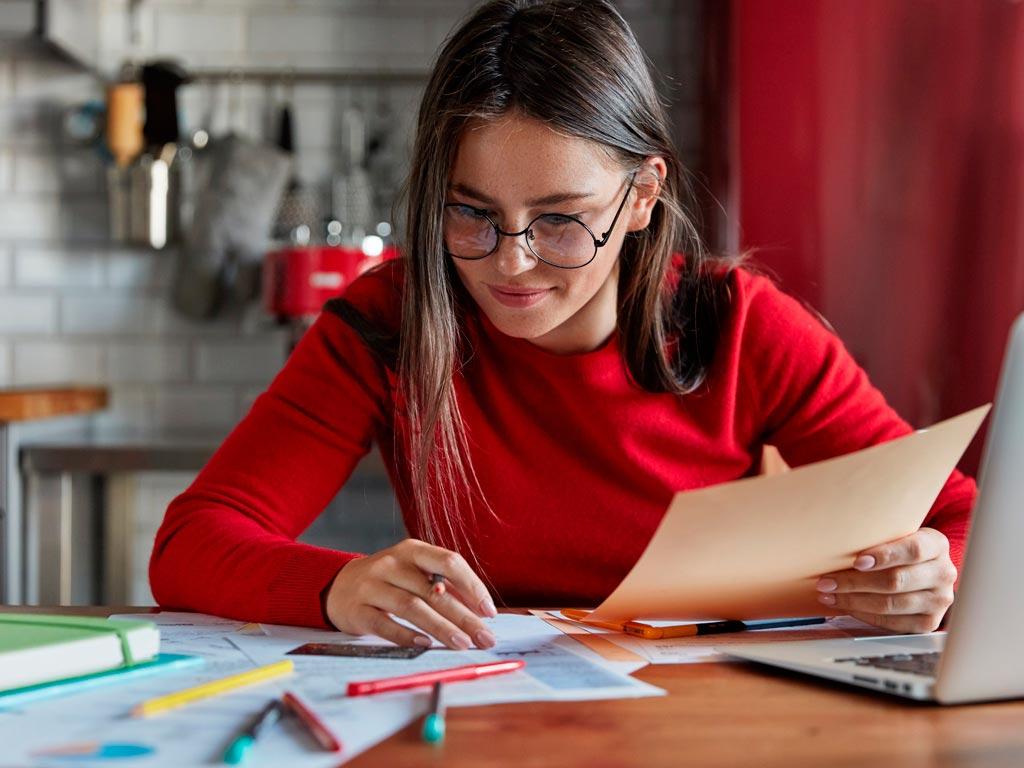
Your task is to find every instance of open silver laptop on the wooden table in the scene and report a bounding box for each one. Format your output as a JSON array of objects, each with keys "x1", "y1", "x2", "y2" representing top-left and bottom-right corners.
[{"x1": 719, "y1": 314, "x2": 1024, "y2": 703}]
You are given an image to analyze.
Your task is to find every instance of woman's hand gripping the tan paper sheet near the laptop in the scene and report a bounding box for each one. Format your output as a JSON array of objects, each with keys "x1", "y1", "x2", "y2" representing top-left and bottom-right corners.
[{"x1": 817, "y1": 528, "x2": 956, "y2": 634}]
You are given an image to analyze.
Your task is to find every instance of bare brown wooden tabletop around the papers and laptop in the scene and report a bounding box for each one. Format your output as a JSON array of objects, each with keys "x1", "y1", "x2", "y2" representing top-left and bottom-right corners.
[{"x1": 0, "y1": 606, "x2": 1024, "y2": 768}]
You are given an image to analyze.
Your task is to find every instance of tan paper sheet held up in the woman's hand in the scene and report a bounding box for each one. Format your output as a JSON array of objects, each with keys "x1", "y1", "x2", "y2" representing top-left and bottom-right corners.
[{"x1": 590, "y1": 406, "x2": 990, "y2": 622}]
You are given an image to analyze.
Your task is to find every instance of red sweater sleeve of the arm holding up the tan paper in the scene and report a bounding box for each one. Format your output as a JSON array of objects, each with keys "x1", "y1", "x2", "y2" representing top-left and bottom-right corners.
[{"x1": 737, "y1": 273, "x2": 977, "y2": 569}]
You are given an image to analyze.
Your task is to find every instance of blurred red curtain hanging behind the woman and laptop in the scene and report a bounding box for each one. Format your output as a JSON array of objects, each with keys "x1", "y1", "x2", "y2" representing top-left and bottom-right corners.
[{"x1": 728, "y1": 0, "x2": 1024, "y2": 474}]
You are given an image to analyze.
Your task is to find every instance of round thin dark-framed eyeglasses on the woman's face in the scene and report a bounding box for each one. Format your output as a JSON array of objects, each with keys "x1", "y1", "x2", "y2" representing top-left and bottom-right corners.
[{"x1": 441, "y1": 173, "x2": 636, "y2": 269}]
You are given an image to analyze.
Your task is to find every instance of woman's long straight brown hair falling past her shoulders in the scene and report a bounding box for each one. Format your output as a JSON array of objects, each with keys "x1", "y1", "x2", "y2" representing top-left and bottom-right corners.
[{"x1": 397, "y1": 0, "x2": 741, "y2": 565}]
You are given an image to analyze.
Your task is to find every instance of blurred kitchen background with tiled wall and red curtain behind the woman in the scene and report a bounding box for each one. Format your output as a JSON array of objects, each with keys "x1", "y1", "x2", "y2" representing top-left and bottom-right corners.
[{"x1": 0, "y1": 0, "x2": 1024, "y2": 604}]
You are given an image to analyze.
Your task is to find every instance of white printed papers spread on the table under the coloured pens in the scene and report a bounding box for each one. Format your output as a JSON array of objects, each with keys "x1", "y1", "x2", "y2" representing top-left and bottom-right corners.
[{"x1": 0, "y1": 613, "x2": 664, "y2": 768}]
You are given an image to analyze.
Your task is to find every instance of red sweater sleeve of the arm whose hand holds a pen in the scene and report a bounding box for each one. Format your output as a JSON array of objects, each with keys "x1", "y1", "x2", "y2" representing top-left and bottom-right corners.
[{"x1": 150, "y1": 312, "x2": 389, "y2": 627}]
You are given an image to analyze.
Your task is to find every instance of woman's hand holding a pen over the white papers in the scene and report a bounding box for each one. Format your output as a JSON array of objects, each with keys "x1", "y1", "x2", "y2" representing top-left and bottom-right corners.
[{"x1": 326, "y1": 539, "x2": 498, "y2": 650}]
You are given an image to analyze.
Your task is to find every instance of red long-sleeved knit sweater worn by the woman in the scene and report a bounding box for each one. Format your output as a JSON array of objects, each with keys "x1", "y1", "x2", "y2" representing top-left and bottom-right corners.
[{"x1": 150, "y1": 262, "x2": 976, "y2": 626}]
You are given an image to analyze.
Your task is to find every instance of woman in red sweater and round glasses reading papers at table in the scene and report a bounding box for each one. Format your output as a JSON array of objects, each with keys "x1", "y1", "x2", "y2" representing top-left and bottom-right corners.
[{"x1": 151, "y1": 0, "x2": 976, "y2": 648}]
